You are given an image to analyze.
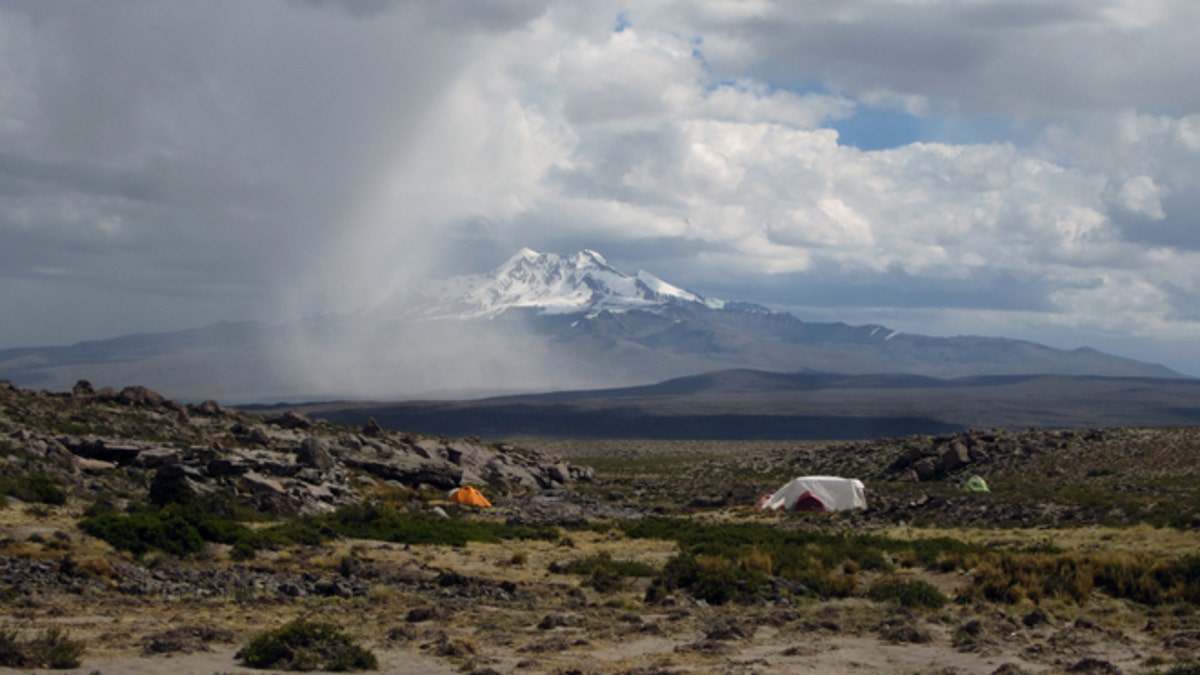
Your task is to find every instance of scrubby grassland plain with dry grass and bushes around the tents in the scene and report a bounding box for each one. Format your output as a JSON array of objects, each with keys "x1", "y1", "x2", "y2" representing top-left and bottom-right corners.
[{"x1": 0, "y1": 381, "x2": 1200, "y2": 675}]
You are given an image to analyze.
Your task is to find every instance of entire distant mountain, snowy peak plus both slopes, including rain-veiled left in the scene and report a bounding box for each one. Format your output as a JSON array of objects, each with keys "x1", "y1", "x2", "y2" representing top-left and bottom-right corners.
[{"x1": 0, "y1": 249, "x2": 1183, "y2": 402}]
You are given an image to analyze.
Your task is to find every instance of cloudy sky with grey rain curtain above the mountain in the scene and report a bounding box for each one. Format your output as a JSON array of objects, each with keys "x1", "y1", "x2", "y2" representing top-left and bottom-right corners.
[{"x1": 0, "y1": 0, "x2": 1200, "y2": 376}]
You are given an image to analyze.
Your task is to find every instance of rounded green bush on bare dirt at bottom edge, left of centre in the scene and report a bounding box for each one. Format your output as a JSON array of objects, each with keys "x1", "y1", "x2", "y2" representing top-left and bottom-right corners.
[{"x1": 235, "y1": 619, "x2": 379, "y2": 671}]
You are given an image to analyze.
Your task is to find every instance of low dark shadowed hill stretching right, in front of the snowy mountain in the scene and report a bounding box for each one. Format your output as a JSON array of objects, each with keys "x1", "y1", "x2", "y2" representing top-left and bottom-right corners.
[{"x1": 272, "y1": 370, "x2": 1200, "y2": 440}]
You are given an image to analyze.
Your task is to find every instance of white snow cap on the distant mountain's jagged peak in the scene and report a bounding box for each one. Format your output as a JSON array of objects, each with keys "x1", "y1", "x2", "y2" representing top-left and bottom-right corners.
[{"x1": 398, "y1": 249, "x2": 725, "y2": 318}]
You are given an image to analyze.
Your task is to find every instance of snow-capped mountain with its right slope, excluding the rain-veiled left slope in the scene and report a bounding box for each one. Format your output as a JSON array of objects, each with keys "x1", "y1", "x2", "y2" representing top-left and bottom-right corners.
[{"x1": 374, "y1": 249, "x2": 1177, "y2": 380}]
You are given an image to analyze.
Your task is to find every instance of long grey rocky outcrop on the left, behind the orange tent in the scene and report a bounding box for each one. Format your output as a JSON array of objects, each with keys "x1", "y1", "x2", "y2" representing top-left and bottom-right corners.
[{"x1": 0, "y1": 381, "x2": 593, "y2": 514}]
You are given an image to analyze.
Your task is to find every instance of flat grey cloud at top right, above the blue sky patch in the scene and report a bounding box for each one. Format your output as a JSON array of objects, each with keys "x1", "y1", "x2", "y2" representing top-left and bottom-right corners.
[{"x1": 700, "y1": 0, "x2": 1200, "y2": 115}]
